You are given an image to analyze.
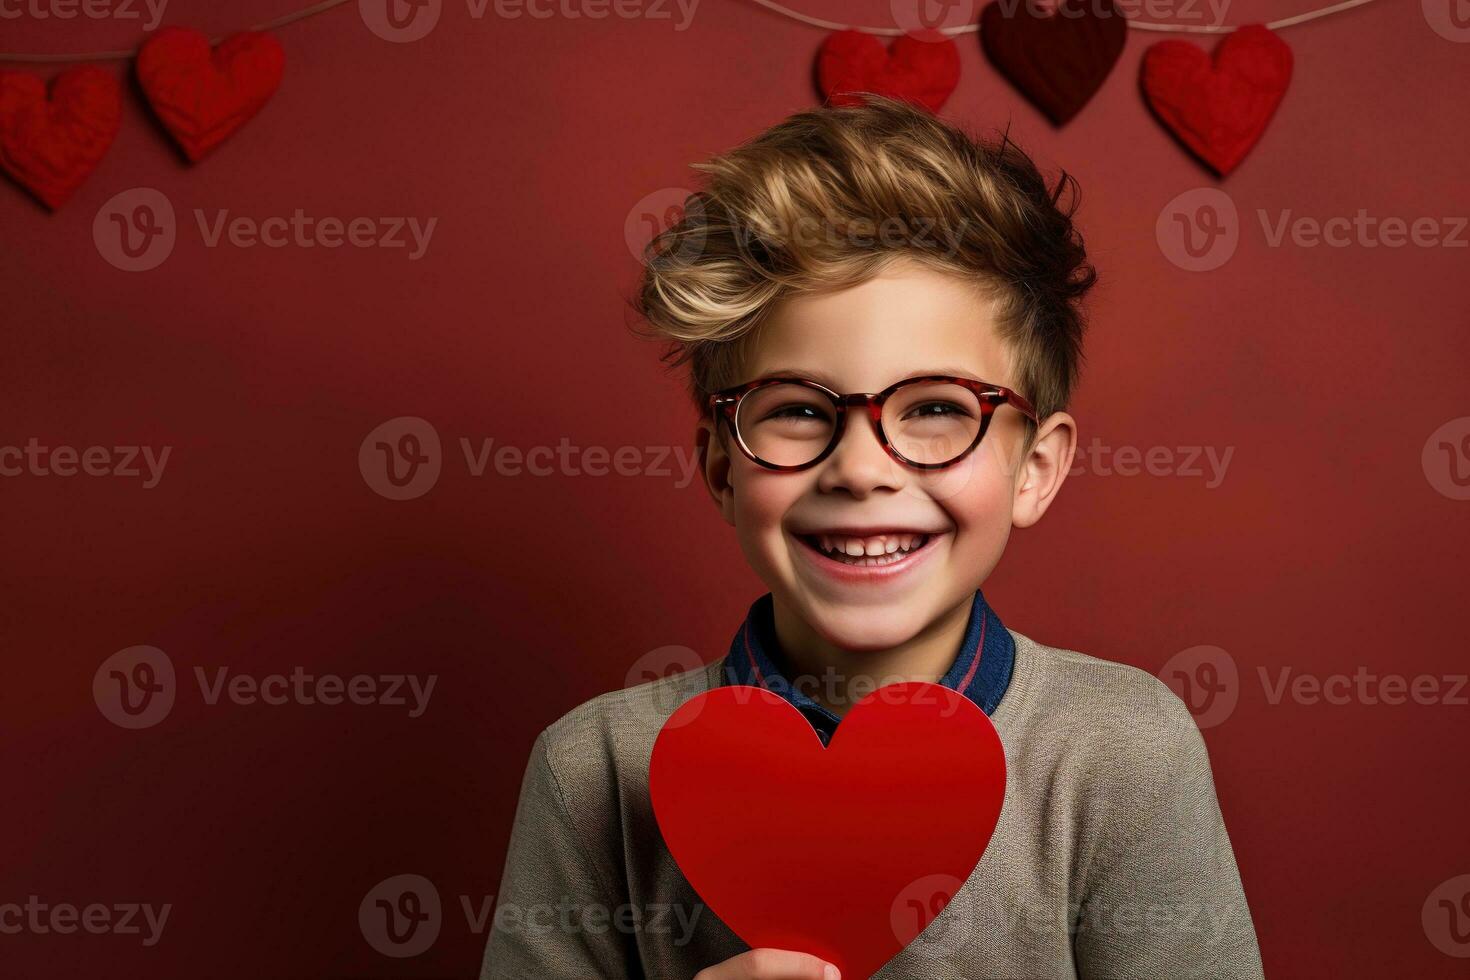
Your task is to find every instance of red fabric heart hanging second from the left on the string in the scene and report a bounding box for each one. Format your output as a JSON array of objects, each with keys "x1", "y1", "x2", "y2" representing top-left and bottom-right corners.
[{"x1": 138, "y1": 28, "x2": 285, "y2": 162}]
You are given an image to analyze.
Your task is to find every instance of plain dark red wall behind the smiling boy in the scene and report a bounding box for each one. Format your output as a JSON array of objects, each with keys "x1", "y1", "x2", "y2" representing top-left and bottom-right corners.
[{"x1": 0, "y1": 0, "x2": 1470, "y2": 977}]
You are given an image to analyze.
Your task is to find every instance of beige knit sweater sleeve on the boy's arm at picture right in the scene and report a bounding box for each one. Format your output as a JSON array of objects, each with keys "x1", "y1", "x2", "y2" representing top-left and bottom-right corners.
[{"x1": 1073, "y1": 677, "x2": 1263, "y2": 980}]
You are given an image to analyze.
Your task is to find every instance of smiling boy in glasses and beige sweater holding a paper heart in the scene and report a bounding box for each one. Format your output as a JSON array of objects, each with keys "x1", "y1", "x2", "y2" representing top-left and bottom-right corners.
[{"x1": 481, "y1": 97, "x2": 1261, "y2": 980}]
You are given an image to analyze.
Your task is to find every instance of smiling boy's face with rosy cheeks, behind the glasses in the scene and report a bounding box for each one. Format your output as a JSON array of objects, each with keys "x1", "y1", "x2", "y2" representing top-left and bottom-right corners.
[{"x1": 700, "y1": 262, "x2": 1076, "y2": 651}]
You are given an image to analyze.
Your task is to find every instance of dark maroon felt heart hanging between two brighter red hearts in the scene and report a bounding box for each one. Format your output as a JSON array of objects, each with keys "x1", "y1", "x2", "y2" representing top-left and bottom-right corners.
[{"x1": 980, "y1": 0, "x2": 1127, "y2": 126}]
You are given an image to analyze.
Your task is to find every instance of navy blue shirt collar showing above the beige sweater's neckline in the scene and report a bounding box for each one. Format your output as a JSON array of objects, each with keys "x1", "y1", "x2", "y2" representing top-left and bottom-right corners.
[{"x1": 725, "y1": 589, "x2": 1016, "y2": 745}]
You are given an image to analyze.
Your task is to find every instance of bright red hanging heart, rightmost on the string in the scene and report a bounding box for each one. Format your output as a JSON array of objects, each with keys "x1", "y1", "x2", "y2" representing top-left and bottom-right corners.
[{"x1": 1141, "y1": 24, "x2": 1292, "y2": 176}]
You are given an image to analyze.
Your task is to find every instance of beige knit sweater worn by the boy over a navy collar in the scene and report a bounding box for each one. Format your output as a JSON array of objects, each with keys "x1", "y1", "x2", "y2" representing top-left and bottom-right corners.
[{"x1": 481, "y1": 630, "x2": 1261, "y2": 980}]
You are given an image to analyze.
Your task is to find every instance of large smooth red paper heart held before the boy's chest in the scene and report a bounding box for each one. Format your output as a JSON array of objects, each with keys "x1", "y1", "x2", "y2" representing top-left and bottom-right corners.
[{"x1": 648, "y1": 683, "x2": 1005, "y2": 980}]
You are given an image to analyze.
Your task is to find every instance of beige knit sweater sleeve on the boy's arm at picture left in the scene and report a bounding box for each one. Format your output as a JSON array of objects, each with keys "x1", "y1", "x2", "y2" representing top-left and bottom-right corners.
[{"x1": 479, "y1": 732, "x2": 637, "y2": 980}]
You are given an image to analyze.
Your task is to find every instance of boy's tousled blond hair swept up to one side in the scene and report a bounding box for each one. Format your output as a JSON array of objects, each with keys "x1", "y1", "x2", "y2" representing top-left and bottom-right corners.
[{"x1": 632, "y1": 94, "x2": 1097, "y2": 440}]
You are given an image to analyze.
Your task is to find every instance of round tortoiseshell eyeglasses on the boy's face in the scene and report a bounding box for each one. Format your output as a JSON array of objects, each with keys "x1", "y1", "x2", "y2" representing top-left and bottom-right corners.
[{"x1": 709, "y1": 375, "x2": 1038, "y2": 470}]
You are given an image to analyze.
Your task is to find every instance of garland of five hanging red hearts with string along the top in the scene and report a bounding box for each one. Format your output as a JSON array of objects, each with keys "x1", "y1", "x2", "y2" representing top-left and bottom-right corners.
[{"x1": 0, "y1": 0, "x2": 1373, "y2": 210}]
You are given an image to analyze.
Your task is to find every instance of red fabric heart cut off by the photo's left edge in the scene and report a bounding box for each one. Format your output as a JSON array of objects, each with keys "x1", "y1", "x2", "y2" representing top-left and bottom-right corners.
[{"x1": 0, "y1": 68, "x2": 122, "y2": 210}]
